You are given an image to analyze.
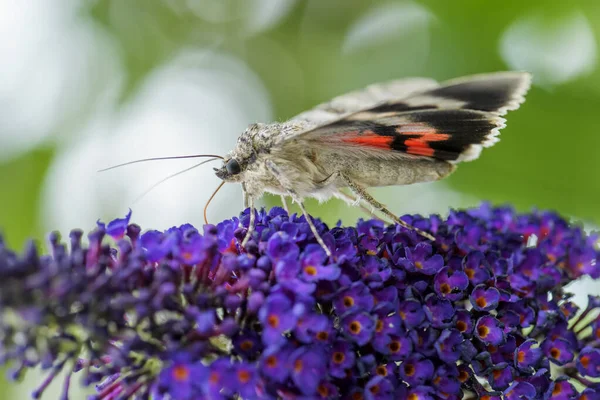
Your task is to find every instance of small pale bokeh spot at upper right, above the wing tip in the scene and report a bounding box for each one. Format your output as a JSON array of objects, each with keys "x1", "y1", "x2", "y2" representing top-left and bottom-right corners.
[{"x1": 499, "y1": 12, "x2": 598, "y2": 85}]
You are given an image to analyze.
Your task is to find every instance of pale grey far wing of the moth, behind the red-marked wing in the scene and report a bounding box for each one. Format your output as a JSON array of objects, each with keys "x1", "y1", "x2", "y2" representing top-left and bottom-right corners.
[{"x1": 291, "y1": 78, "x2": 439, "y2": 125}]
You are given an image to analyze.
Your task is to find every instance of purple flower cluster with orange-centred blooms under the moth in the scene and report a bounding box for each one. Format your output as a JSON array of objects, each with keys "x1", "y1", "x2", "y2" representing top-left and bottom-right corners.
[{"x1": 0, "y1": 204, "x2": 600, "y2": 400}]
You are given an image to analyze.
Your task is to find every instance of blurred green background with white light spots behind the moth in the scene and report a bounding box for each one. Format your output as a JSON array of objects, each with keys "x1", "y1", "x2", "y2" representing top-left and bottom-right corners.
[{"x1": 0, "y1": 0, "x2": 600, "y2": 399}]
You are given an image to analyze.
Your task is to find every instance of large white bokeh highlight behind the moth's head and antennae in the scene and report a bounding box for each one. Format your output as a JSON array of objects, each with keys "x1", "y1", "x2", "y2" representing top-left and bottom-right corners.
[{"x1": 40, "y1": 51, "x2": 271, "y2": 238}]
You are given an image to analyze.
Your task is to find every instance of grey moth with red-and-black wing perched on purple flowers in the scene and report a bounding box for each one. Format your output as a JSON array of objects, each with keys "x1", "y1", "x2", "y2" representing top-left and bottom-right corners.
[{"x1": 106, "y1": 72, "x2": 531, "y2": 256}]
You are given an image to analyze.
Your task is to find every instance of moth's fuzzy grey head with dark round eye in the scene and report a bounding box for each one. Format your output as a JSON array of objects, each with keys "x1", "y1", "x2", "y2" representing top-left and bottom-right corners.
[{"x1": 214, "y1": 124, "x2": 261, "y2": 182}]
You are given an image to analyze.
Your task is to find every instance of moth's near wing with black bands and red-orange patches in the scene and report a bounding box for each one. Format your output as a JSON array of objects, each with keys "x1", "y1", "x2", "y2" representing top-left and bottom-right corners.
[{"x1": 293, "y1": 72, "x2": 531, "y2": 162}]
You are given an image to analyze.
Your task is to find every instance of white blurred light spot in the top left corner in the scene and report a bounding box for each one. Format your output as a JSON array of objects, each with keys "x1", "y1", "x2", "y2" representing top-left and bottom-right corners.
[{"x1": 0, "y1": 0, "x2": 120, "y2": 161}]
